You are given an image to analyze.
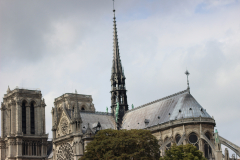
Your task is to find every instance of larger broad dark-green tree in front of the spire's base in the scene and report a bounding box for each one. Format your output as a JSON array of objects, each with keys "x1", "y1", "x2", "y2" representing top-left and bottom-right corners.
[{"x1": 80, "y1": 129, "x2": 160, "y2": 160}]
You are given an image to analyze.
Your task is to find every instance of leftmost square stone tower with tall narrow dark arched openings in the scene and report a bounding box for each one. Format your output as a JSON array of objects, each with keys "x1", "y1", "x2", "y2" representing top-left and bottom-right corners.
[{"x1": 0, "y1": 87, "x2": 48, "y2": 160}]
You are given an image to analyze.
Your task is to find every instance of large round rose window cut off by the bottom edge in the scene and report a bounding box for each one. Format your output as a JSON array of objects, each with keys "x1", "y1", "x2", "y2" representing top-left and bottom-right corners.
[{"x1": 57, "y1": 143, "x2": 73, "y2": 160}]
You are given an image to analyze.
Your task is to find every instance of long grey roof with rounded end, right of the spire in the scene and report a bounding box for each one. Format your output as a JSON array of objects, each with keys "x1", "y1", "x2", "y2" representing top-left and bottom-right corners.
[{"x1": 122, "y1": 90, "x2": 211, "y2": 129}]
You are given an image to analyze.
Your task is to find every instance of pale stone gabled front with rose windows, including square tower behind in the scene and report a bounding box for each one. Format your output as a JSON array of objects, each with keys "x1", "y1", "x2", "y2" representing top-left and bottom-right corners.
[{"x1": 51, "y1": 93, "x2": 95, "y2": 160}]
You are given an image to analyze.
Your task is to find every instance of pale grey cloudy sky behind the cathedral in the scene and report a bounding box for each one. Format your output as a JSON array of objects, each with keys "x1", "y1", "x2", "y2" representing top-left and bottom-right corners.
[{"x1": 0, "y1": 0, "x2": 240, "y2": 155}]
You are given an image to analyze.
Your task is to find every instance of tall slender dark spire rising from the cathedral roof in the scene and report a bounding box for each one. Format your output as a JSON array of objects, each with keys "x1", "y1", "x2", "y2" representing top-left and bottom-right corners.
[{"x1": 110, "y1": 10, "x2": 128, "y2": 129}]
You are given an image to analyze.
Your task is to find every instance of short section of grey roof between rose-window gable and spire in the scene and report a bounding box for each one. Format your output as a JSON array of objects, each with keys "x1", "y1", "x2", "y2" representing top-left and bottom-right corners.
[{"x1": 80, "y1": 111, "x2": 116, "y2": 133}]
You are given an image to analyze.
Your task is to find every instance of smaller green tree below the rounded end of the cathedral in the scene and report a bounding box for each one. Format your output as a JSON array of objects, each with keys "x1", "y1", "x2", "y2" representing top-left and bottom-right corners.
[{"x1": 159, "y1": 144, "x2": 207, "y2": 160}]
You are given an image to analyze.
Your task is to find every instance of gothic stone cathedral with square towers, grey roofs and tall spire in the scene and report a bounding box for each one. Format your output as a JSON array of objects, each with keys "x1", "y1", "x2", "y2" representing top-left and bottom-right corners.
[{"x1": 0, "y1": 10, "x2": 240, "y2": 160}]
